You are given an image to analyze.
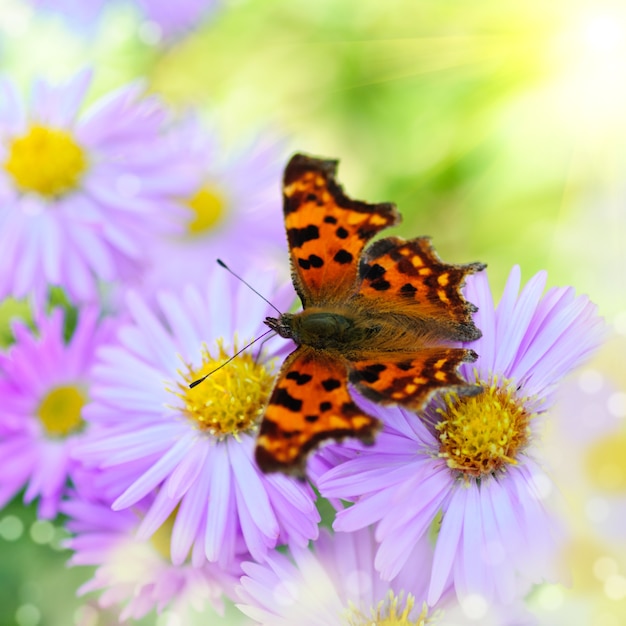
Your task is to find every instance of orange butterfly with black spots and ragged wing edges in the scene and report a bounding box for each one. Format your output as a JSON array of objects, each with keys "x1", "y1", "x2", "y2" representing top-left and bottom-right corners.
[{"x1": 255, "y1": 154, "x2": 485, "y2": 478}]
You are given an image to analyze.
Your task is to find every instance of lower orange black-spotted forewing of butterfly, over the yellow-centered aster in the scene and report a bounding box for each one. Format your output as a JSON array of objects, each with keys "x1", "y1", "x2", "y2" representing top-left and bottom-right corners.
[{"x1": 256, "y1": 346, "x2": 380, "y2": 478}]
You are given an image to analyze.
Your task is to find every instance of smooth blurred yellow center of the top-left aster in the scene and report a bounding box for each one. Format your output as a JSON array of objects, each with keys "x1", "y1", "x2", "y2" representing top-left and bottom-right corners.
[{"x1": 4, "y1": 125, "x2": 87, "y2": 198}]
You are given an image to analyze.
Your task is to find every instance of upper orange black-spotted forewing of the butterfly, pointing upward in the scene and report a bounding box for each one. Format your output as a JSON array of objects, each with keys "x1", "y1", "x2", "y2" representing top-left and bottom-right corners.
[{"x1": 283, "y1": 154, "x2": 400, "y2": 308}]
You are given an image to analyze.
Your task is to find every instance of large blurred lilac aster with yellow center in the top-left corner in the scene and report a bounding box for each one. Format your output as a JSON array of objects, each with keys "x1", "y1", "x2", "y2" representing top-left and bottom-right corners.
[{"x1": 0, "y1": 72, "x2": 195, "y2": 300}]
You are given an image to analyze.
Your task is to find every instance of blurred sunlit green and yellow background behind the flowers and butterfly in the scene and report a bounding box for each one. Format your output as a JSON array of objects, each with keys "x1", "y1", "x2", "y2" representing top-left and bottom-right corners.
[{"x1": 0, "y1": 0, "x2": 626, "y2": 626}]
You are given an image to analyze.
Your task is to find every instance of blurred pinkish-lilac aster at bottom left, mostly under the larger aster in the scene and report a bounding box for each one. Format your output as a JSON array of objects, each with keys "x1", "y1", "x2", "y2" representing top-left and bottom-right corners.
[{"x1": 61, "y1": 494, "x2": 241, "y2": 624}]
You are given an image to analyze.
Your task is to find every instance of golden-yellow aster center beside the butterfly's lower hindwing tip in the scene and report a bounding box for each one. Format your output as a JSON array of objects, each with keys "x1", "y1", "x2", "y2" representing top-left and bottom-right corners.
[{"x1": 436, "y1": 377, "x2": 534, "y2": 478}]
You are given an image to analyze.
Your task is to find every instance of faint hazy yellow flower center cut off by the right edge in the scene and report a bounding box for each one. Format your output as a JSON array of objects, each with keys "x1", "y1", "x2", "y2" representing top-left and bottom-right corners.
[{"x1": 585, "y1": 433, "x2": 626, "y2": 494}]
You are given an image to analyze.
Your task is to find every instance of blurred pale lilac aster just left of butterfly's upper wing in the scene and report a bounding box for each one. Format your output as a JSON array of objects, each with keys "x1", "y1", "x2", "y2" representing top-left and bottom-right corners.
[{"x1": 142, "y1": 117, "x2": 285, "y2": 293}]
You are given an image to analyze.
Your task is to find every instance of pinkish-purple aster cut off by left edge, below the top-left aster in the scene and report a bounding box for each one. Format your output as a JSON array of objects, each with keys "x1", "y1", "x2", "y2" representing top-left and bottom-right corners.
[{"x1": 0, "y1": 308, "x2": 111, "y2": 518}]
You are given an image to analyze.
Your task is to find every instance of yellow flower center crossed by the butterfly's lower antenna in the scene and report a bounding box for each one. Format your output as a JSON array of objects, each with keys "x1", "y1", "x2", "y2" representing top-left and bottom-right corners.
[{"x1": 174, "y1": 342, "x2": 274, "y2": 438}]
